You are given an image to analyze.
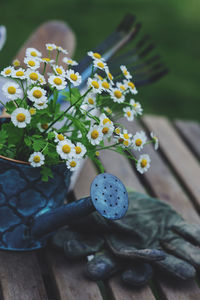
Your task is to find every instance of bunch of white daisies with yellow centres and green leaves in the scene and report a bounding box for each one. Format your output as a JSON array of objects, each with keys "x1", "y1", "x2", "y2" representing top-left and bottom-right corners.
[{"x1": 0, "y1": 44, "x2": 158, "y2": 181}]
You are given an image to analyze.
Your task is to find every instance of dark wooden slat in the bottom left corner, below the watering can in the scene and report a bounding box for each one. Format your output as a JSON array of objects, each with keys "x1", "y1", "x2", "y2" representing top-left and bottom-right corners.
[{"x1": 0, "y1": 251, "x2": 48, "y2": 300}]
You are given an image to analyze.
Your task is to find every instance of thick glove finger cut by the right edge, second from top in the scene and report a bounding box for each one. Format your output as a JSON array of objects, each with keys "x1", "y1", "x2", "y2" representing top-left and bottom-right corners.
[{"x1": 160, "y1": 234, "x2": 200, "y2": 267}]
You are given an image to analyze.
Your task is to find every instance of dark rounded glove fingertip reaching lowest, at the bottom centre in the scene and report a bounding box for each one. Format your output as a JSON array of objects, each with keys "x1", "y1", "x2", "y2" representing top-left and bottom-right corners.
[{"x1": 122, "y1": 262, "x2": 153, "y2": 287}]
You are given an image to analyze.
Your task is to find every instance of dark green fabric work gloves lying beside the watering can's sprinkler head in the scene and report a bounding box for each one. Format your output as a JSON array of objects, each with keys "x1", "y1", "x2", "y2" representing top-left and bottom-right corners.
[{"x1": 52, "y1": 191, "x2": 200, "y2": 286}]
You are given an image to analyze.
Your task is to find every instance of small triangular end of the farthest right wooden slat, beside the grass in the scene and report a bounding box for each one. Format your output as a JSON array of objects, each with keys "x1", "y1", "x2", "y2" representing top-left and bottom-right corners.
[{"x1": 174, "y1": 120, "x2": 200, "y2": 159}]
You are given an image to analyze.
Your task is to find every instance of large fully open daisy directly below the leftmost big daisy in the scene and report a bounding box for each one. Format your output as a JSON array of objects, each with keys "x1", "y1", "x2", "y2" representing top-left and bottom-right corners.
[{"x1": 11, "y1": 108, "x2": 31, "y2": 128}]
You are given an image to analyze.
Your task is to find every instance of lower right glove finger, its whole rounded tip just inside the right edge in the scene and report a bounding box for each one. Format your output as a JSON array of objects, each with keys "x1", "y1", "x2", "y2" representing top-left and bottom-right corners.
[{"x1": 153, "y1": 253, "x2": 196, "y2": 280}]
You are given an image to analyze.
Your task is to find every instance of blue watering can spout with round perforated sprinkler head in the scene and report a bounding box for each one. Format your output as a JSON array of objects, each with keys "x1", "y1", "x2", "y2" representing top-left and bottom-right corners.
[{"x1": 29, "y1": 173, "x2": 128, "y2": 238}]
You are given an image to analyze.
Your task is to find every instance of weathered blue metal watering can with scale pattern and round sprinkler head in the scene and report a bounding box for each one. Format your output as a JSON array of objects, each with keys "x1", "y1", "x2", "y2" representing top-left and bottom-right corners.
[{"x1": 0, "y1": 156, "x2": 128, "y2": 251}]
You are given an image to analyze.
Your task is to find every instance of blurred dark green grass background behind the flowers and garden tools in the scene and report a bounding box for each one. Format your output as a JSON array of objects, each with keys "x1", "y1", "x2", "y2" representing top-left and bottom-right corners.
[{"x1": 0, "y1": 0, "x2": 200, "y2": 121}]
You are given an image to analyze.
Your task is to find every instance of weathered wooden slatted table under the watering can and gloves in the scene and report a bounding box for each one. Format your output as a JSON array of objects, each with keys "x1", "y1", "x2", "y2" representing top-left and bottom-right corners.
[{"x1": 0, "y1": 116, "x2": 200, "y2": 300}]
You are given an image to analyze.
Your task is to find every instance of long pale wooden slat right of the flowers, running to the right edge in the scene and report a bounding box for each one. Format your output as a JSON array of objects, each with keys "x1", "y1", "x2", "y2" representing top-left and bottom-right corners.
[{"x1": 143, "y1": 116, "x2": 200, "y2": 211}]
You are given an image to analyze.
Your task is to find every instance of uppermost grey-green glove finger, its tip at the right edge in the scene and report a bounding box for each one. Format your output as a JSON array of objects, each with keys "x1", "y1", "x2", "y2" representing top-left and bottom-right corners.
[{"x1": 172, "y1": 222, "x2": 200, "y2": 245}]
